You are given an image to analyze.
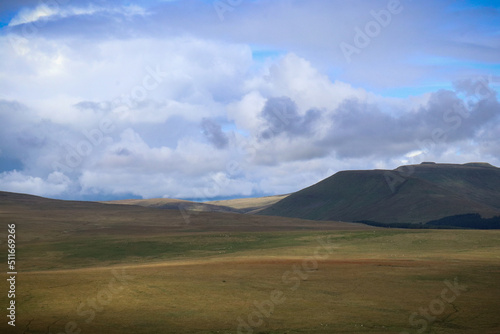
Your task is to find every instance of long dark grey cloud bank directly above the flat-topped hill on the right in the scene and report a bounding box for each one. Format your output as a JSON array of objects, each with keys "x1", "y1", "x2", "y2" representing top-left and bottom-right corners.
[{"x1": 320, "y1": 90, "x2": 500, "y2": 158}]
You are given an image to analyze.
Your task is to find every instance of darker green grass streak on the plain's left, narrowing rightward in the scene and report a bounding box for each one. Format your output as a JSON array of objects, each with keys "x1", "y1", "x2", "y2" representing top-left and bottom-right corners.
[{"x1": 19, "y1": 232, "x2": 316, "y2": 270}]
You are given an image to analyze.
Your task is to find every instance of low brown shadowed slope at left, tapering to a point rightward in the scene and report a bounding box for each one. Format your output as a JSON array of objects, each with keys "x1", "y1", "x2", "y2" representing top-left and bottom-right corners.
[{"x1": 0, "y1": 191, "x2": 373, "y2": 243}]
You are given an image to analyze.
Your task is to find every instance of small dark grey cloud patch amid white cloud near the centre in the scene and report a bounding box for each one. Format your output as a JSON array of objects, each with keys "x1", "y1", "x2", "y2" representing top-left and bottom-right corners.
[{"x1": 261, "y1": 97, "x2": 321, "y2": 139}]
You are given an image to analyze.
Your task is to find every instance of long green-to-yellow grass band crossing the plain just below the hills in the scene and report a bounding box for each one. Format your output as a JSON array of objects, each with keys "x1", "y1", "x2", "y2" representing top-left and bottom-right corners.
[{"x1": 18, "y1": 229, "x2": 500, "y2": 271}]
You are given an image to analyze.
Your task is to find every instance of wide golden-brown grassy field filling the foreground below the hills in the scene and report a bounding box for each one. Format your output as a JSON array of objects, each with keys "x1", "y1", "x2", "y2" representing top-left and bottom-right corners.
[{"x1": 0, "y1": 228, "x2": 500, "y2": 333}]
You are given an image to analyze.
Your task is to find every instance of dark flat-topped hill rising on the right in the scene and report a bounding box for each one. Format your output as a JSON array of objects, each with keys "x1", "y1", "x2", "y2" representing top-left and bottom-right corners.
[{"x1": 260, "y1": 163, "x2": 500, "y2": 224}]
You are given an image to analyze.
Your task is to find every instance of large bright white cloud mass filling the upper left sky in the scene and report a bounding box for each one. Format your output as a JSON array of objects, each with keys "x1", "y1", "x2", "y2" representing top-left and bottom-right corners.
[{"x1": 0, "y1": 36, "x2": 251, "y2": 124}]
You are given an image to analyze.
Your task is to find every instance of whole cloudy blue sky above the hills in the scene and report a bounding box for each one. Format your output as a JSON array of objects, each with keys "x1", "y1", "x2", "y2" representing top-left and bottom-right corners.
[{"x1": 0, "y1": 0, "x2": 500, "y2": 201}]
